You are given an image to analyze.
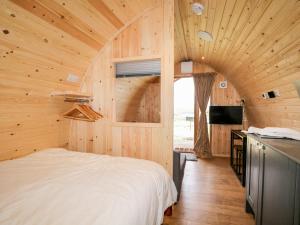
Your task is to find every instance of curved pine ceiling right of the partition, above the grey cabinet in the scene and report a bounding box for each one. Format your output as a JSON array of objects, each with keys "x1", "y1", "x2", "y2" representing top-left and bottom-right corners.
[{"x1": 175, "y1": 0, "x2": 300, "y2": 129}]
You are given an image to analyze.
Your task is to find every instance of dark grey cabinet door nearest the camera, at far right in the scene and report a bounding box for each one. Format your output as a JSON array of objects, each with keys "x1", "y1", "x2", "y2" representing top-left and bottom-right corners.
[{"x1": 257, "y1": 146, "x2": 296, "y2": 225}]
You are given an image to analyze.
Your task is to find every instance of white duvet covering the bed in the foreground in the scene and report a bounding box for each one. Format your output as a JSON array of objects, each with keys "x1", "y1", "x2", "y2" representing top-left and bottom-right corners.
[{"x1": 0, "y1": 149, "x2": 177, "y2": 225}]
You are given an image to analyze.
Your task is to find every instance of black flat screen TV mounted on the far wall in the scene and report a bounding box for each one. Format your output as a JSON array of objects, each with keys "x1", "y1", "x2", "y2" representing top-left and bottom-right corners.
[{"x1": 209, "y1": 106, "x2": 243, "y2": 124}]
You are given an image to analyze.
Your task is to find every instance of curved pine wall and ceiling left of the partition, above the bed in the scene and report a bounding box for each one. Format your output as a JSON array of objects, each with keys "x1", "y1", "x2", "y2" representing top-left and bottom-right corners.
[{"x1": 0, "y1": 0, "x2": 158, "y2": 160}]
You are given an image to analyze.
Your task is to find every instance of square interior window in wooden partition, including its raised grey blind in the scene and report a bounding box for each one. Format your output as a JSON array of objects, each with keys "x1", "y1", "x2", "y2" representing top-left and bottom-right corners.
[{"x1": 115, "y1": 59, "x2": 161, "y2": 123}]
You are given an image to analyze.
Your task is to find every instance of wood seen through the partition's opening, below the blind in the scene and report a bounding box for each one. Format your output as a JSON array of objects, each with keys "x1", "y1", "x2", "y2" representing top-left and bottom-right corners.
[{"x1": 115, "y1": 77, "x2": 160, "y2": 123}]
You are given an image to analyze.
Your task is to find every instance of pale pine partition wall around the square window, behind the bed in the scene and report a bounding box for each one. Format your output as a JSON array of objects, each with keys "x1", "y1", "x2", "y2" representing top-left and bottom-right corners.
[{"x1": 69, "y1": 0, "x2": 174, "y2": 173}]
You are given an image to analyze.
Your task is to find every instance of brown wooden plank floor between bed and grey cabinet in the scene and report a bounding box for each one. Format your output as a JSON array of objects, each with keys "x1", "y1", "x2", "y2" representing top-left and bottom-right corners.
[{"x1": 164, "y1": 158, "x2": 254, "y2": 225}]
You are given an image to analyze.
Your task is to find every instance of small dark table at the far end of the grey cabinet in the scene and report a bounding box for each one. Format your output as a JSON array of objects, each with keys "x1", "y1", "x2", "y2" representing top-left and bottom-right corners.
[{"x1": 230, "y1": 130, "x2": 247, "y2": 187}]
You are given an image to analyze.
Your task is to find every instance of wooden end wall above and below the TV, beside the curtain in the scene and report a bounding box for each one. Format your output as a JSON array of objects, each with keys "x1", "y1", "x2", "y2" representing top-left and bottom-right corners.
[{"x1": 210, "y1": 74, "x2": 242, "y2": 157}]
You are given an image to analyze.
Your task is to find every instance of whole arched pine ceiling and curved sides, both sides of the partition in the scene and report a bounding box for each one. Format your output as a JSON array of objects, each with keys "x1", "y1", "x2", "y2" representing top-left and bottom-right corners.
[{"x1": 0, "y1": 0, "x2": 300, "y2": 158}]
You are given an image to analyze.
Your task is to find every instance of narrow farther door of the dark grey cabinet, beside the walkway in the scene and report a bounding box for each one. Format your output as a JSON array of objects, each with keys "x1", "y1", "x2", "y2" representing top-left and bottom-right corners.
[{"x1": 246, "y1": 138, "x2": 259, "y2": 215}]
